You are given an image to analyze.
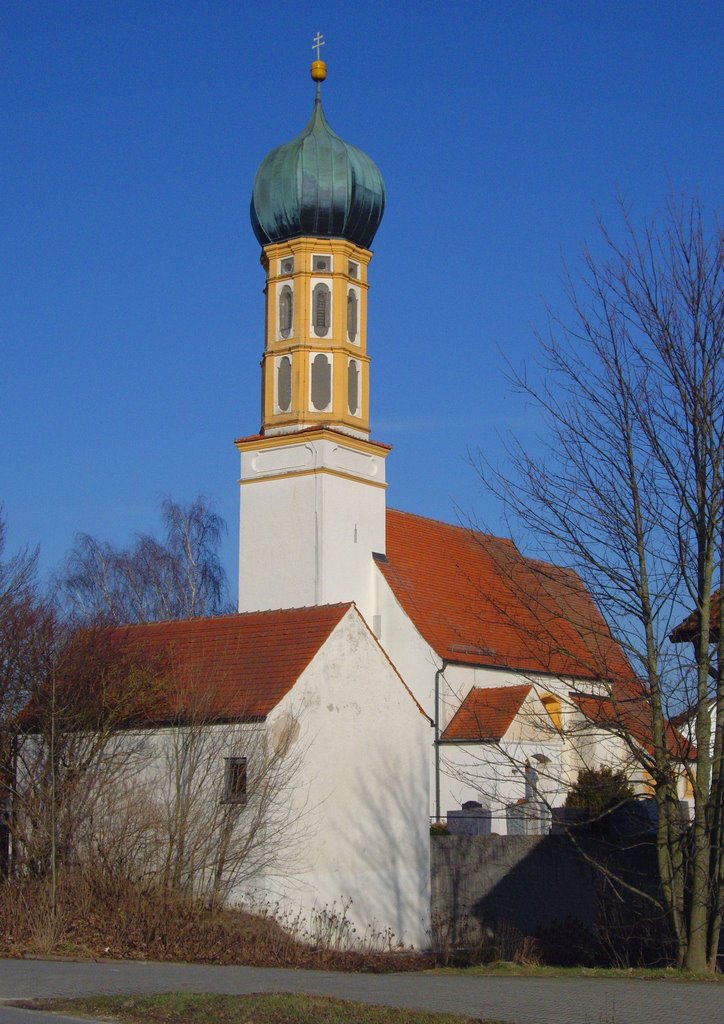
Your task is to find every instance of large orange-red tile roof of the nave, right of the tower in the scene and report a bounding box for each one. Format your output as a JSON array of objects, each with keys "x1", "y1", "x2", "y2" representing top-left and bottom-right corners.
[{"x1": 377, "y1": 509, "x2": 634, "y2": 680}]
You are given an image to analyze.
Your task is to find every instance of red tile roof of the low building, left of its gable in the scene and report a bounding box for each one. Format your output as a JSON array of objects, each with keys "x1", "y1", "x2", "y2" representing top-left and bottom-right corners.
[{"x1": 113, "y1": 604, "x2": 353, "y2": 720}]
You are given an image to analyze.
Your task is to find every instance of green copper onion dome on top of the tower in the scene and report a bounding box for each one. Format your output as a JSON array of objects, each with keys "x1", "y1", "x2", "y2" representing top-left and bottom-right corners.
[{"x1": 251, "y1": 92, "x2": 385, "y2": 249}]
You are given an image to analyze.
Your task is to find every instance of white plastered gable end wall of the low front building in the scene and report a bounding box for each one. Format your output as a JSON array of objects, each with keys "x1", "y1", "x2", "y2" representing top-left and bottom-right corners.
[{"x1": 269, "y1": 609, "x2": 432, "y2": 946}]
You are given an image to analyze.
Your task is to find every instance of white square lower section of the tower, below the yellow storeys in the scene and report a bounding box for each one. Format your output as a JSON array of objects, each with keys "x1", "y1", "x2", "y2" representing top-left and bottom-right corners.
[{"x1": 239, "y1": 439, "x2": 385, "y2": 621}]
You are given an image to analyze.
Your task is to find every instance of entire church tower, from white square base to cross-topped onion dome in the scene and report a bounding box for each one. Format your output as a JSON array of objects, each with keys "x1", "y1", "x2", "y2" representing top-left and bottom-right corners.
[{"x1": 237, "y1": 33, "x2": 389, "y2": 613}]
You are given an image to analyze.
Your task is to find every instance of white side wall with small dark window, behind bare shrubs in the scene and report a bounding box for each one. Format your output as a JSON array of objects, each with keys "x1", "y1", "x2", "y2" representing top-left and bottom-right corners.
[{"x1": 17, "y1": 714, "x2": 286, "y2": 898}]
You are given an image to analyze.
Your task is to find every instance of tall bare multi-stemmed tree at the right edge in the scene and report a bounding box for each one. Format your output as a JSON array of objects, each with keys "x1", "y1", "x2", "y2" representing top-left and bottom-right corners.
[{"x1": 479, "y1": 199, "x2": 724, "y2": 971}]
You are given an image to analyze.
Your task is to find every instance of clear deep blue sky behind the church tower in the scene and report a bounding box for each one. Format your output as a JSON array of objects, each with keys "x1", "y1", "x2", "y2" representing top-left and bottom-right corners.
[{"x1": 0, "y1": 0, "x2": 724, "y2": 598}]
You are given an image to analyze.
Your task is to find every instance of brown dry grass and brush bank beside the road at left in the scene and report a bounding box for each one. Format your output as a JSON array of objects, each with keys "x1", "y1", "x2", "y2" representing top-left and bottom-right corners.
[{"x1": 0, "y1": 871, "x2": 430, "y2": 971}]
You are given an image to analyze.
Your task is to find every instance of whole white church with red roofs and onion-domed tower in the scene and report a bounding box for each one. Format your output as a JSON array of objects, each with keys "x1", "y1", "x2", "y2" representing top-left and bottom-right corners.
[{"x1": 104, "y1": 51, "x2": 671, "y2": 946}]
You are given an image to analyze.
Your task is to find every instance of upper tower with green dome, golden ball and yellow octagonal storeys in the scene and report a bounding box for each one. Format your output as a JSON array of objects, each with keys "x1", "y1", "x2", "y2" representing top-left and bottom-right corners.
[{"x1": 251, "y1": 44, "x2": 385, "y2": 437}]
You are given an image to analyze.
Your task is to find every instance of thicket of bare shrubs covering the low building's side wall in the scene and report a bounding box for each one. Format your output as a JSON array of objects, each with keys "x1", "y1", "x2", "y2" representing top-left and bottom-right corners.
[{"x1": 12, "y1": 627, "x2": 308, "y2": 917}]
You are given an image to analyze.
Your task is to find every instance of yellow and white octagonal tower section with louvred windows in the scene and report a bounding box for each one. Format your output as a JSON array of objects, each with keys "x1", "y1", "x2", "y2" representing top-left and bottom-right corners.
[{"x1": 261, "y1": 238, "x2": 372, "y2": 437}]
